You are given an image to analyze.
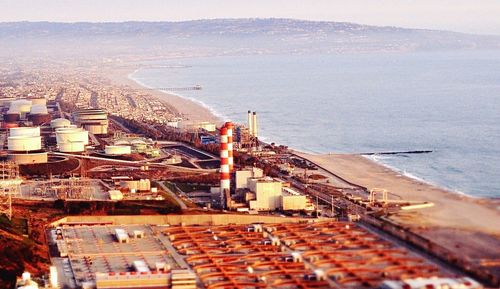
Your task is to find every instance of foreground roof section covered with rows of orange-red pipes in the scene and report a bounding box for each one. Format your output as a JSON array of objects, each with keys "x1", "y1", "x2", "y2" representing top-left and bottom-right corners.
[{"x1": 164, "y1": 218, "x2": 472, "y2": 289}]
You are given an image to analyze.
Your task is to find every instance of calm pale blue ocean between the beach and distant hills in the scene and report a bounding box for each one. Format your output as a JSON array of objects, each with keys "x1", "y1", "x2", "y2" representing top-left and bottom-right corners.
[{"x1": 130, "y1": 51, "x2": 500, "y2": 198}]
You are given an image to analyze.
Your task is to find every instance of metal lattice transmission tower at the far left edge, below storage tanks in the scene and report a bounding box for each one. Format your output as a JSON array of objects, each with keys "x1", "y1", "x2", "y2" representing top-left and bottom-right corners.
[{"x1": 0, "y1": 162, "x2": 22, "y2": 220}]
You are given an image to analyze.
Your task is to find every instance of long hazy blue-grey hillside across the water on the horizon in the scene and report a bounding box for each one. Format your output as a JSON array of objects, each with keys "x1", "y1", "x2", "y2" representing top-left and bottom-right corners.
[{"x1": 0, "y1": 19, "x2": 500, "y2": 56}]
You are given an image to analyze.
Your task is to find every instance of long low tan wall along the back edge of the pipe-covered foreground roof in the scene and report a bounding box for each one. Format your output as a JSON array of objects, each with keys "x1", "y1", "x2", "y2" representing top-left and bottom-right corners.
[{"x1": 52, "y1": 214, "x2": 308, "y2": 226}]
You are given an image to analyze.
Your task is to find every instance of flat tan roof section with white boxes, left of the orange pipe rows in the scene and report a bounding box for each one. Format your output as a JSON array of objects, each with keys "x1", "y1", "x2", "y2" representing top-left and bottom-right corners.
[{"x1": 49, "y1": 223, "x2": 184, "y2": 289}]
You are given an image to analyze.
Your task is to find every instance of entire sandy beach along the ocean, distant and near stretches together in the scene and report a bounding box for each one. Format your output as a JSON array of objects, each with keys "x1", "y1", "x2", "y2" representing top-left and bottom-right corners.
[{"x1": 102, "y1": 63, "x2": 500, "y2": 261}]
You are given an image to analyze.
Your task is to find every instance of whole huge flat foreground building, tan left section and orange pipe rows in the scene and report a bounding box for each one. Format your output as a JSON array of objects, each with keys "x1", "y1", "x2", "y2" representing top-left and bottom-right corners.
[{"x1": 50, "y1": 215, "x2": 483, "y2": 289}]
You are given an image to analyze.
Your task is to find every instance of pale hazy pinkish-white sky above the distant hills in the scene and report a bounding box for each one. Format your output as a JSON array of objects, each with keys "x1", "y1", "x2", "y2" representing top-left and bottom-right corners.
[{"x1": 0, "y1": 0, "x2": 500, "y2": 34}]
